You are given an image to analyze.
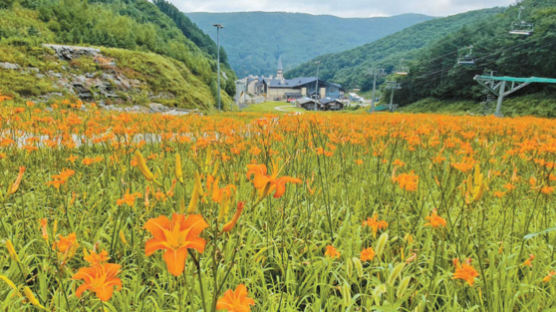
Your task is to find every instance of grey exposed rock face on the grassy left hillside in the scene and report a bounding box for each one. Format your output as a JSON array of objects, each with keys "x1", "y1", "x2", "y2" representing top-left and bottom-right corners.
[{"x1": 4, "y1": 44, "x2": 182, "y2": 115}]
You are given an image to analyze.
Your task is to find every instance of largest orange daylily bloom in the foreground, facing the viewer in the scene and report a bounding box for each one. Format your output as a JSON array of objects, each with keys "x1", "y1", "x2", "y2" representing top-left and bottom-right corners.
[{"x1": 144, "y1": 213, "x2": 208, "y2": 276}]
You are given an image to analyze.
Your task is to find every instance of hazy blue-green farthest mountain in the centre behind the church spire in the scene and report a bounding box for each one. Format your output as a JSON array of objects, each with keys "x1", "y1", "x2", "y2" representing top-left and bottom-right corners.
[{"x1": 186, "y1": 12, "x2": 432, "y2": 77}]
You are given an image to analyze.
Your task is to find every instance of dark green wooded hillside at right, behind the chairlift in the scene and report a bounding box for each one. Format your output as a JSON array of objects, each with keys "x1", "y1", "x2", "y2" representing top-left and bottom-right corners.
[{"x1": 398, "y1": 0, "x2": 556, "y2": 104}]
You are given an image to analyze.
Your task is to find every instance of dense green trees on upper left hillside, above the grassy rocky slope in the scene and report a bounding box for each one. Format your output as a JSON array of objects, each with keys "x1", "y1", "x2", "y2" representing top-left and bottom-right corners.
[{"x1": 0, "y1": 0, "x2": 236, "y2": 105}]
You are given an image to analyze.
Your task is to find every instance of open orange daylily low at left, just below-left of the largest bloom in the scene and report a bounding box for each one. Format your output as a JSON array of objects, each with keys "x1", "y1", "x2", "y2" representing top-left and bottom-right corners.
[{"x1": 72, "y1": 263, "x2": 122, "y2": 301}]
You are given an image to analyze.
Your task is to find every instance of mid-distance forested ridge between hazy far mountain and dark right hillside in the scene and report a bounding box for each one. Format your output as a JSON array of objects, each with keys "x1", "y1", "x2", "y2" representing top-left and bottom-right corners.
[{"x1": 286, "y1": 8, "x2": 503, "y2": 91}]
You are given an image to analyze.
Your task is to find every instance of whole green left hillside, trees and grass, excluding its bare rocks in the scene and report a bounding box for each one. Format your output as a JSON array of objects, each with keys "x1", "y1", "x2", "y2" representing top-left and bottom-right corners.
[{"x1": 0, "y1": 0, "x2": 235, "y2": 108}]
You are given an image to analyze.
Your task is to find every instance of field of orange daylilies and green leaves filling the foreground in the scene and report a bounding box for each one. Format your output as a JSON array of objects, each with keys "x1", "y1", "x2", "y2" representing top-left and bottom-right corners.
[{"x1": 0, "y1": 96, "x2": 556, "y2": 312}]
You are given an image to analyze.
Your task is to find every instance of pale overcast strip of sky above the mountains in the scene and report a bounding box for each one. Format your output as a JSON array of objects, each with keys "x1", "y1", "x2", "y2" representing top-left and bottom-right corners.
[{"x1": 169, "y1": 0, "x2": 516, "y2": 17}]
